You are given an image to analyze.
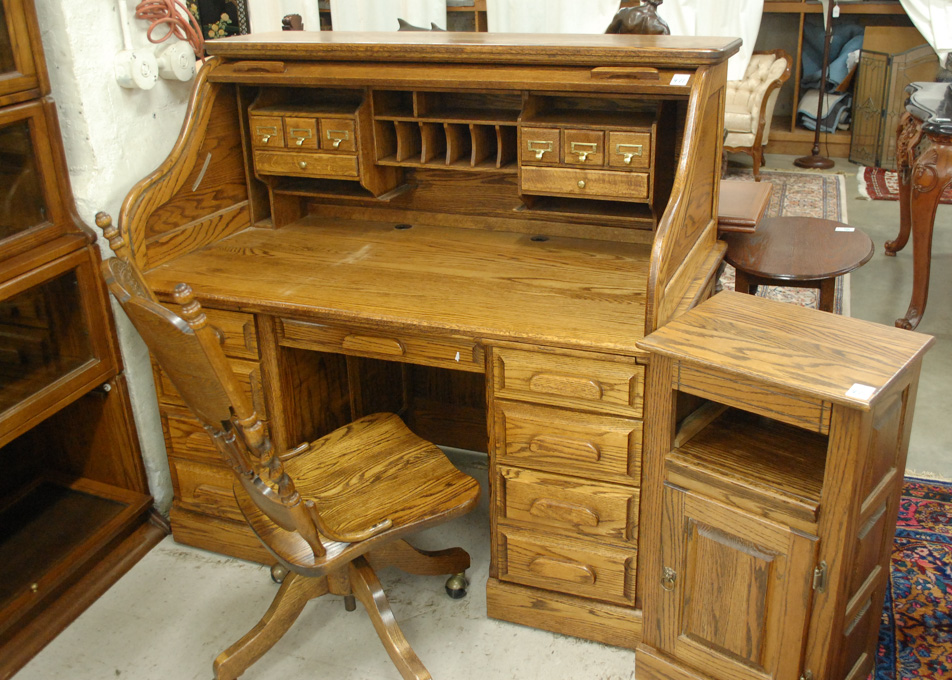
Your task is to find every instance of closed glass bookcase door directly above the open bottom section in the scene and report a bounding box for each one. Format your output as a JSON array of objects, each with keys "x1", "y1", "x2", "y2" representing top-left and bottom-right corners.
[{"x1": 0, "y1": 245, "x2": 115, "y2": 447}]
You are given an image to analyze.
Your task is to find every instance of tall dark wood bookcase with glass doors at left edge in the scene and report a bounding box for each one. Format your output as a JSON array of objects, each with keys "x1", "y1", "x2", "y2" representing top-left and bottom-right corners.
[{"x1": 0, "y1": 0, "x2": 165, "y2": 678}]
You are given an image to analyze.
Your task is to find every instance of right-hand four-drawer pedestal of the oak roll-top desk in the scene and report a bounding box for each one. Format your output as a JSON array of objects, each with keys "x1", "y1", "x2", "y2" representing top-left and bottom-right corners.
[{"x1": 487, "y1": 345, "x2": 644, "y2": 648}]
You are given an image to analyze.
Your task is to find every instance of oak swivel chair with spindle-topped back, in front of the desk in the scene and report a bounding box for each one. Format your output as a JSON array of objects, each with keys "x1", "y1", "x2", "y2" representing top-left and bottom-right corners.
[{"x1": 97, "y1": 218, "x2": 479, "y2": 680}]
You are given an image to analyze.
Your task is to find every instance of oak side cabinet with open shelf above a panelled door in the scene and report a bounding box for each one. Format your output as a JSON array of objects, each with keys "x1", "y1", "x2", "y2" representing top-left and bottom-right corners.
[{"x1": 636, "y1": 292, "x2": 933, "y2": 680}]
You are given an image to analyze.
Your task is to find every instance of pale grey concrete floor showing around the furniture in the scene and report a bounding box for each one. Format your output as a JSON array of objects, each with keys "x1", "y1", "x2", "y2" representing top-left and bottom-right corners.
[{"x1": 16, "y1": 156, "x2": 952, "y2": 680}]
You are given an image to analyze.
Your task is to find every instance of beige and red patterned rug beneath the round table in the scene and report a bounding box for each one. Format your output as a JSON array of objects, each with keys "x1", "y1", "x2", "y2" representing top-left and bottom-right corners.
[{"x1": 719, "y1": 170, "x2": 849, "y2": 316}]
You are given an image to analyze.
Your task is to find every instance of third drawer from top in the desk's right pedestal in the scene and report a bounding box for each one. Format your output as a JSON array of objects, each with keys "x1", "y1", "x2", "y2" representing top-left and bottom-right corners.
[{"x1": 496, "y1": 466, "x2": 639, "y2": 544}]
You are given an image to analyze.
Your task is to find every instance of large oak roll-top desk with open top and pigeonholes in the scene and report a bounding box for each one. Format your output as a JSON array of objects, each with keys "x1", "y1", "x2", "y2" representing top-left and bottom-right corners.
[{"x1": 111, "y1": 32, "x2": 739, "y2": 648}]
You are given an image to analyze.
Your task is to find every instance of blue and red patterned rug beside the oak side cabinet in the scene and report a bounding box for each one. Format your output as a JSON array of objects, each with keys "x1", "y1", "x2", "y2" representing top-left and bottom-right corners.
[{"x1": 873, "y1": 477, "x2": 952, "y2": 680}]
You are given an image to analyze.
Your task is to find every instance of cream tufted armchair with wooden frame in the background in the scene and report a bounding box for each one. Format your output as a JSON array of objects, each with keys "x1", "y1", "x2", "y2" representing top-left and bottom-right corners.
[{"x1": 724, "y1": 50, "x2": 793, "y2": 182}]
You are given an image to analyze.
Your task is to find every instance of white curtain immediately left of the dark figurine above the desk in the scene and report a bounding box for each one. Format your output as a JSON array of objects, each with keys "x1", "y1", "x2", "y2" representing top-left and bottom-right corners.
[{"x1": 486, "y1": 0, "x2": 620, "y2": 33}]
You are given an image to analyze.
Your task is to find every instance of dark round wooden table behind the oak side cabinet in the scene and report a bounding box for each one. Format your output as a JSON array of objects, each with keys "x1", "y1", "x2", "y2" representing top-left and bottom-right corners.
[{"x1": 722, "y1": 217, "x2": 873, "y2": 312}]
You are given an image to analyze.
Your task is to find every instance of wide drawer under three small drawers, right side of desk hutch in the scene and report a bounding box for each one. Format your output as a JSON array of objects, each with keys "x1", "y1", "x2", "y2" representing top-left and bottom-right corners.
[{"x1": 522, "y1": 166, "x2": 648, "y2": 202}]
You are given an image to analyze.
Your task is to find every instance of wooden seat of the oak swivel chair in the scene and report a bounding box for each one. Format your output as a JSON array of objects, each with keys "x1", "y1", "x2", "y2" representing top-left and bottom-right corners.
[{"x1": 235, "y1": 413, "x2": 479, "y2": 573}]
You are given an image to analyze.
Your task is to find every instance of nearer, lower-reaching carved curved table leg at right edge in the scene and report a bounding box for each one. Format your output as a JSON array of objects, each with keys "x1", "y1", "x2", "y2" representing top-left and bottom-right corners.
[{"x1": 896, "y1": 133, "x2": 952, "y2": 330}]
